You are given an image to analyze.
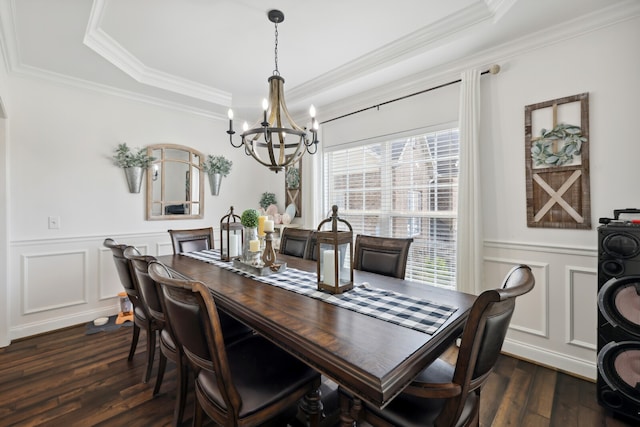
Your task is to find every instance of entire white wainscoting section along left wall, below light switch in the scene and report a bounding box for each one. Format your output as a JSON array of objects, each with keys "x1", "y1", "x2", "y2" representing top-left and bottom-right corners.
[{"x1": 7, "y1": 231, "x2": 171, "y2": 340}]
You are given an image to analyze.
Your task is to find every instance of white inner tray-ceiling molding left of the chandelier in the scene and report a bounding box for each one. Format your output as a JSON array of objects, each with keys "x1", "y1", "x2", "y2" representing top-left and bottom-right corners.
[{"x1": 83, "y1": 0, "x2": 232, "y2": 107}]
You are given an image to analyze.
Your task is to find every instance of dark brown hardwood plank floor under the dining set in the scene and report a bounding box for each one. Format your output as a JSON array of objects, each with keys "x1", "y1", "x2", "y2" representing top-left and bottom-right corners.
[{"x1": 0, "y1": 325, "x2": 634, "y2": 427}]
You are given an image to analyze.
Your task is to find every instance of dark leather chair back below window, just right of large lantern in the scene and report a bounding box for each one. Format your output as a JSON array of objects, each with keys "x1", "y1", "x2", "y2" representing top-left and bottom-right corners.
[{"x1": 353, "y1": 234, "x2": 413, "y2": 279}]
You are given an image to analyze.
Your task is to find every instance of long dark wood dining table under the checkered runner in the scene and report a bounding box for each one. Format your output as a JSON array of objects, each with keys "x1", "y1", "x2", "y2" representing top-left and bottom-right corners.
[{"x1": 158, "y1": 254, "x2": 475, "y2": 422}]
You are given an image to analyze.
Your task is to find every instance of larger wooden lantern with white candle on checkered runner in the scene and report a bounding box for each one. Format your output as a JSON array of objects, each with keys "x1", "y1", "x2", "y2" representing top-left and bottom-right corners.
[{"x1": 316, "y1": 205, "x2": 353, "y2": 294}]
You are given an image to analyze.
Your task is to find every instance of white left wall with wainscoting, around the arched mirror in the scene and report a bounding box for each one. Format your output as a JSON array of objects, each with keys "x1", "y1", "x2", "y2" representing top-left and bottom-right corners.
[{"x1": 0, "y1": 75, "x2": 284, "y2": 344}]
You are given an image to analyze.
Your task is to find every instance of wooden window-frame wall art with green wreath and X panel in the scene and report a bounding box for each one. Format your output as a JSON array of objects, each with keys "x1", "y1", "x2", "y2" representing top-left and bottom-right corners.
[{"x1": 524, "y1": 93, "x2": 591, "y2": 229}]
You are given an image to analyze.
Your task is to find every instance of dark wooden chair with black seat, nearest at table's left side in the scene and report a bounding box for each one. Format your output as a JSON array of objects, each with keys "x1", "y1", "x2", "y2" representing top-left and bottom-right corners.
[{"x1": 149, "y1": 262, "x2": 320, "y2": 426}]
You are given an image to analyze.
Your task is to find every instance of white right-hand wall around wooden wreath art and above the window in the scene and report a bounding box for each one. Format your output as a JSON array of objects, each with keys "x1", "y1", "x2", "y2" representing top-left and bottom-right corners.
[{"x1": 323, "y1": 13, "x2": 640, "y2": 378}]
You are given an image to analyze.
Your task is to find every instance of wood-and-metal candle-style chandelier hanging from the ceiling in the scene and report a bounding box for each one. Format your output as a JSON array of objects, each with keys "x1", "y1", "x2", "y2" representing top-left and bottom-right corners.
[{"x1": 227, "y1": 10, "x2": 319, "y2": 173}]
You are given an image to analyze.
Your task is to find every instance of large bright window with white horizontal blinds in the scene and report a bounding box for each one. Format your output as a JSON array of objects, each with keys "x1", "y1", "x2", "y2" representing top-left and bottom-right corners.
[{"x1": 323, "y1": 129, "x2": 459, "y2": 288}]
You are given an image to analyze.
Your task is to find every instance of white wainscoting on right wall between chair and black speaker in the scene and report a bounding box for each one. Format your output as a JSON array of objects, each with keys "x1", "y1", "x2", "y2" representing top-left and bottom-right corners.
[{"x1": 484, "y1": 239, "x2": 598, "y2": 379}]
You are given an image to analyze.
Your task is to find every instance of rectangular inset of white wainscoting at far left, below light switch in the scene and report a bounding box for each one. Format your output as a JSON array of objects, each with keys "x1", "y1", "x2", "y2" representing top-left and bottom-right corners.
[{"x1": 22, "y1": 251, "x2": 88, "y2": 314}]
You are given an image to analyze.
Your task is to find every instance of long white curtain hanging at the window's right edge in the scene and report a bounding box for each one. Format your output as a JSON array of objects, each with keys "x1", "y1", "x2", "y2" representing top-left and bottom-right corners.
[{"x1": 456, "y1": 70, "x2": 483, "y2": 294}]
